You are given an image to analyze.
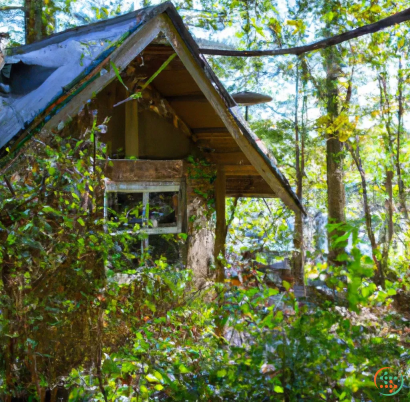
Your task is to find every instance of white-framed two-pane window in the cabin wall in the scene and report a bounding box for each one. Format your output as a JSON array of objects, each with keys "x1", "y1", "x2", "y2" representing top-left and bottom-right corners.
[{"x1": 104, "y1": 181, "x2": 183, "y2": 235}]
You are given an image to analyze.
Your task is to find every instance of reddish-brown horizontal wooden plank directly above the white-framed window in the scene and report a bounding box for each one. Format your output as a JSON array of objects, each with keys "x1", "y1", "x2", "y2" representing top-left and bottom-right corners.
[{"x1": 104, "y1": 159, "x2": 183, "y2": 182}]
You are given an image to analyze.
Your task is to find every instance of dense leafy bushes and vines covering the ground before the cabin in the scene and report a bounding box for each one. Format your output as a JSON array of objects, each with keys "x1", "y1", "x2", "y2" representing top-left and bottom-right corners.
[{"x1": 0, "y1": 127, "x2": 409, "y2": 401}]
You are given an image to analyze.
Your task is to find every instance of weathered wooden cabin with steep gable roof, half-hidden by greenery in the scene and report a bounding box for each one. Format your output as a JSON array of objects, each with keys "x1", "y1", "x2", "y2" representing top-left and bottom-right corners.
[{"x1": 0, "y1": 3, "x2": 303, "y2": 280}]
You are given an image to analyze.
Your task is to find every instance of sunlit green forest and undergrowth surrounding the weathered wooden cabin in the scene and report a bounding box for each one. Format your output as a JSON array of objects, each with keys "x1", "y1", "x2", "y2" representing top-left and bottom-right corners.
[{"x1": 0, "y1": 0, "x2": 410, "y2": 402}]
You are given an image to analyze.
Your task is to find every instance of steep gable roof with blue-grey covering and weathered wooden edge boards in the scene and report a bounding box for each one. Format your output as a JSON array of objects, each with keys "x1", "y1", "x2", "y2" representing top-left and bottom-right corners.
[{"x1": 0, "y1": 2, "x2": 305, "y2": 213}]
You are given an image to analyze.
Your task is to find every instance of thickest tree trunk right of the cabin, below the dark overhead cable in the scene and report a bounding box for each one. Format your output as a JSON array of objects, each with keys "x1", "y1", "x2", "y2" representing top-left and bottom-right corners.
[{"x1": 325, "y1": 48, "x2": 346, "y2": 265}]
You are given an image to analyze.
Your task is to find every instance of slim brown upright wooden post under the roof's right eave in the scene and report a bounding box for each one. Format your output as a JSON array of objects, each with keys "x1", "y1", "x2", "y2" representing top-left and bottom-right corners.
[{"x1": 214, "y1": 165, "x2": 226, "y2": 282}]
